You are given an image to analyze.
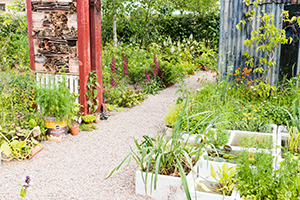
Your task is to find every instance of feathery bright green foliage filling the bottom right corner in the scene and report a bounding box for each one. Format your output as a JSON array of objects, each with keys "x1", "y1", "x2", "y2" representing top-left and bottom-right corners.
[{"x1": 236, "y1": 151, "x2": 300, "y2": 200}]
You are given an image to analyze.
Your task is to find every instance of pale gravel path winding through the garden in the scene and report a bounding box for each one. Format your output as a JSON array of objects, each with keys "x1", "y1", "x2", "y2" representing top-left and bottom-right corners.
[{"x1": 0, "y1": 73, "x2": 216, "y2": 200}]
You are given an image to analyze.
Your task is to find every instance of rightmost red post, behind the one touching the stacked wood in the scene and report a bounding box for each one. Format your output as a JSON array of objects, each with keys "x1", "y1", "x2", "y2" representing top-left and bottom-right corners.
[{"x1": 90, "y1": 0, "x2": 103, "y2": 112}]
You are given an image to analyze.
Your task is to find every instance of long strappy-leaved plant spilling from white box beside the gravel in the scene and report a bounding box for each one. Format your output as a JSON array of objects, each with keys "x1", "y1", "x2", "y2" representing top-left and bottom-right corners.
[{"x1": 107, "y1": 101, "x2": 218, "y2": 199}]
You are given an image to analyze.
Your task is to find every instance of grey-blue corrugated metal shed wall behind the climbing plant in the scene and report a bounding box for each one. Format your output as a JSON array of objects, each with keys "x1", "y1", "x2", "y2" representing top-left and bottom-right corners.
[{"x1": 219, "y1": 0, "x2": 300, "y2": 85}]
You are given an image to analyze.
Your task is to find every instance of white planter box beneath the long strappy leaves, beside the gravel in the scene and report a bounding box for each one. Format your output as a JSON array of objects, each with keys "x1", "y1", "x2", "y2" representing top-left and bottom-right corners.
[{"x1": 135, "y1": 170, "x2": 192, "y2": 200}]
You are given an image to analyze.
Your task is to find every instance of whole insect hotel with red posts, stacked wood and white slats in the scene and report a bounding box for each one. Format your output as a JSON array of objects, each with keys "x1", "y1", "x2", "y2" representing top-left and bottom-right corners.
[{"x1": 26, "y1": 0, "x2": 103, "y2": 114}]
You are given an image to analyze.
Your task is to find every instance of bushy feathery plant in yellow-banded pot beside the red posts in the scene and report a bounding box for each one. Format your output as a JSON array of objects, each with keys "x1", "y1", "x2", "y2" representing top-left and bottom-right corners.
[{"x1": 36, "y1": 80, "x2": 75, "y2": 140}]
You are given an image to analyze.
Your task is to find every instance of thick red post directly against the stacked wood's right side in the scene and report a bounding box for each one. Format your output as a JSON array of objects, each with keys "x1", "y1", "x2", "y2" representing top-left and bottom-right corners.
[{"x1": 77, "y1": 0, "x2": 91, "y2": 114}]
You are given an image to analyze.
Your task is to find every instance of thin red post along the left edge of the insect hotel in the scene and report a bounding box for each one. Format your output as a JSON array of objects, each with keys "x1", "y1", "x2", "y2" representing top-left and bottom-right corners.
[{"x1": 26, "y1": 0, "x2": 35, "y2": 71}]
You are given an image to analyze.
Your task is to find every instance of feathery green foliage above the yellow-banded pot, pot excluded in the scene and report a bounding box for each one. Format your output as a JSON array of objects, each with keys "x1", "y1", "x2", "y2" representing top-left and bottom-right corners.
[{"x1": 36, "y1": 80, "x2": 75, "y2": 120}]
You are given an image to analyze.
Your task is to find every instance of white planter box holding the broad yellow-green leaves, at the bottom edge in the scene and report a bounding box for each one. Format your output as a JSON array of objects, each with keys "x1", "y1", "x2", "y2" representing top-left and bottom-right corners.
[{"x1": 188, "y1": 158, "x2": 239, "y2": 200}]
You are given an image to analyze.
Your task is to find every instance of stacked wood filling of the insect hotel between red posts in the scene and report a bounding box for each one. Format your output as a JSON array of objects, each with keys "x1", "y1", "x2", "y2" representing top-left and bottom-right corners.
[{"x1": 31, "y1": 0, "x2": 79, "y2": 74}]
